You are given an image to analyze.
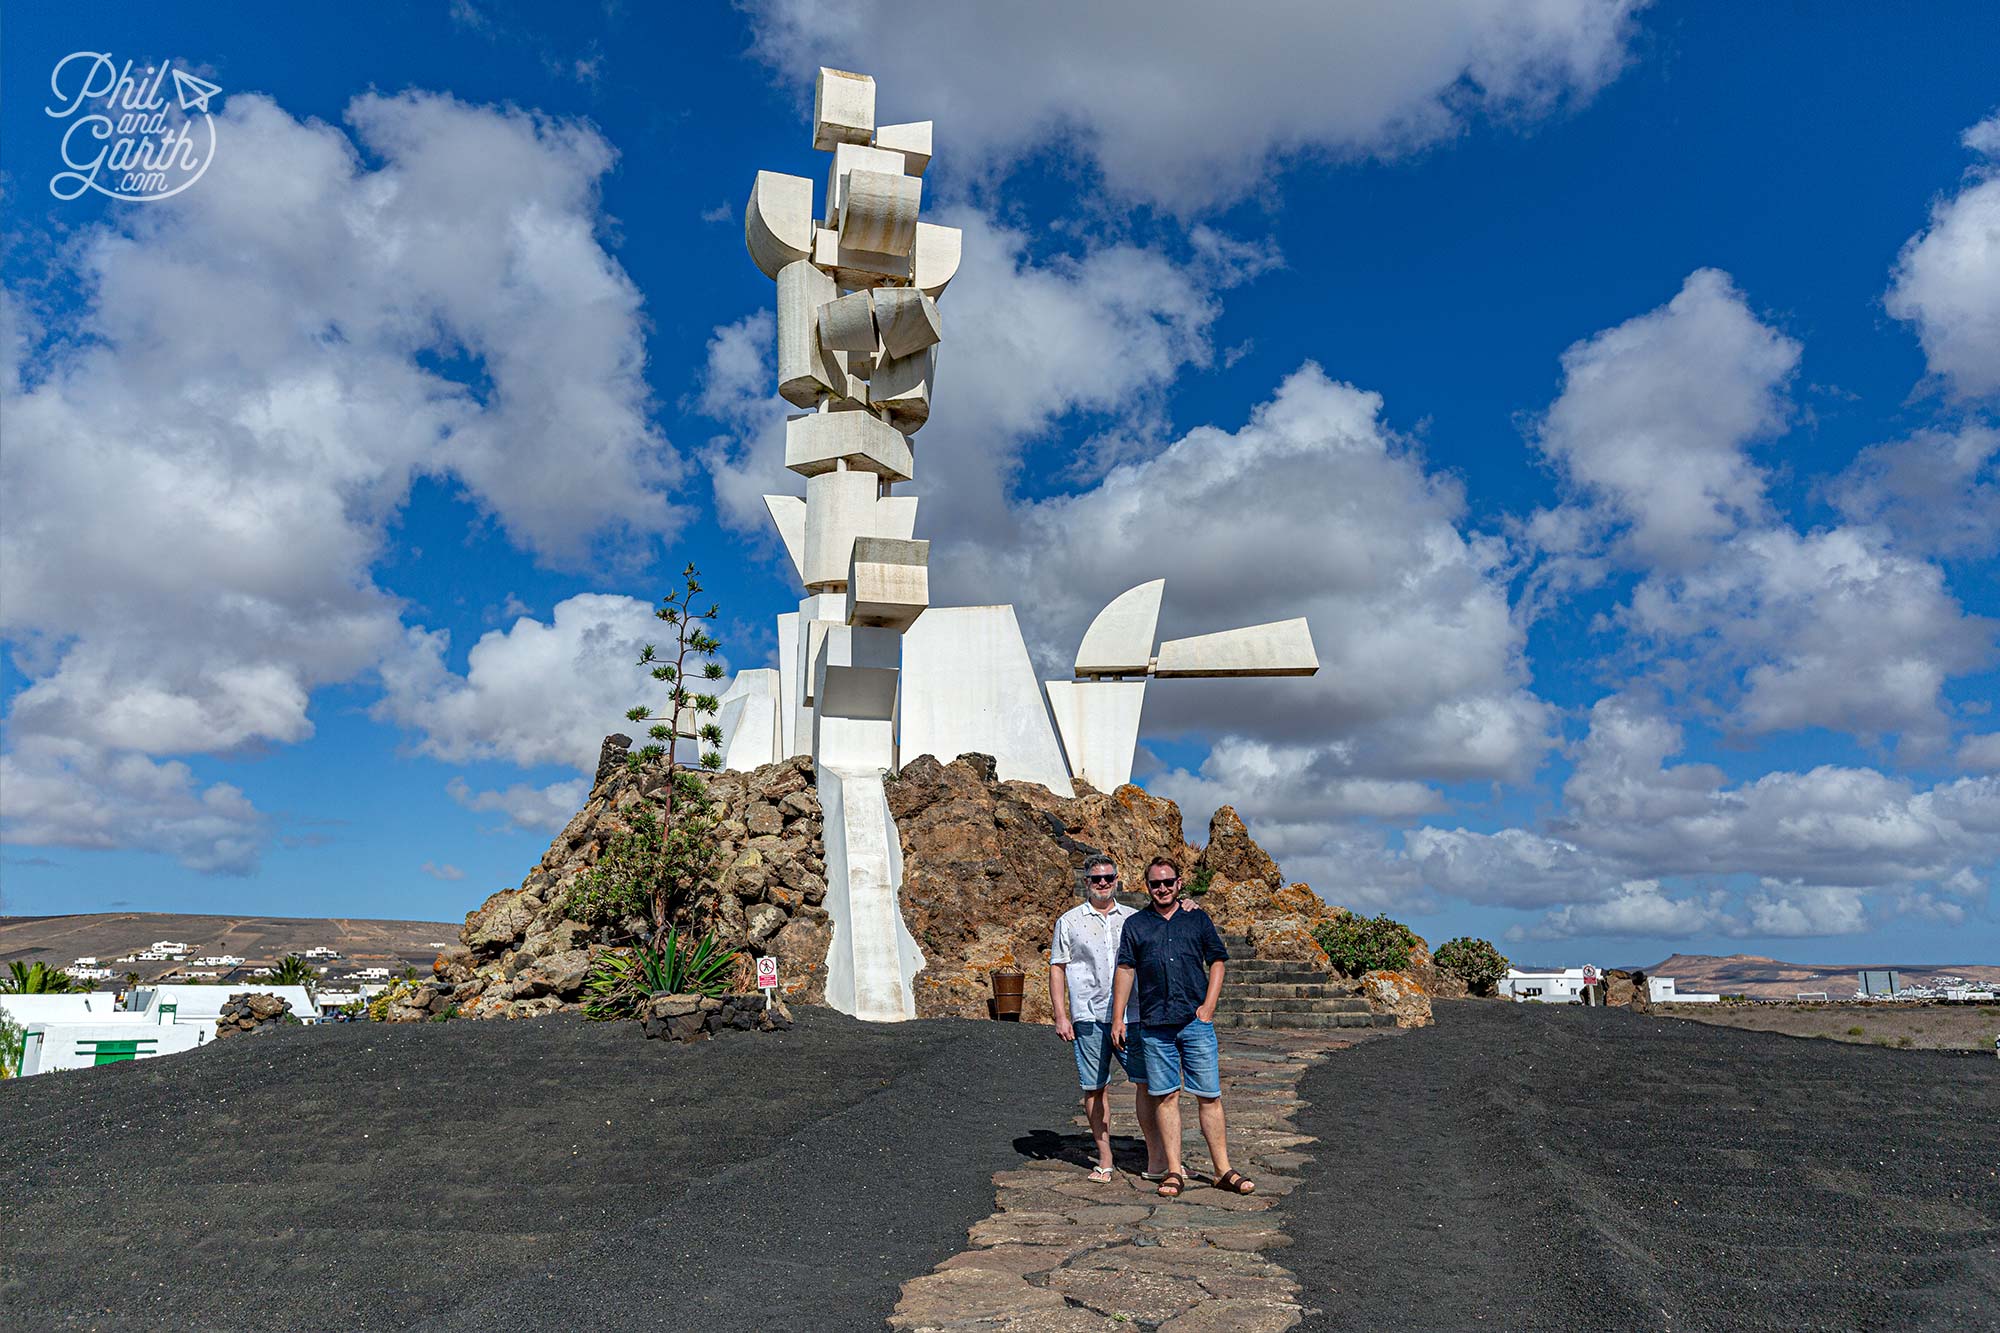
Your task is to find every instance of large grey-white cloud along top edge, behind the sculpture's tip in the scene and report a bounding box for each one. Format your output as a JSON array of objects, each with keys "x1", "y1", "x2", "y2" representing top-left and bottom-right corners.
[{"x1": 750, "y1": 0, "x2": 1638, "y2": 214}]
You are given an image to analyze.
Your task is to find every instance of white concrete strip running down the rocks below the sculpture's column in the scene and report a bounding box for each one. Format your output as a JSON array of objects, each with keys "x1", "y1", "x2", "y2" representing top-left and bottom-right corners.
[{"x1": 820, "y1": 765, "x2": 924, "y2": 1023}]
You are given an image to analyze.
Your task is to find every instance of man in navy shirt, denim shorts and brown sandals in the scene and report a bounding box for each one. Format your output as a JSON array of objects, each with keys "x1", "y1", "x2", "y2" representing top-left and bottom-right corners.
[{"x1": 1112, "y1": 857, "x2": 1256, "y2": 1199}]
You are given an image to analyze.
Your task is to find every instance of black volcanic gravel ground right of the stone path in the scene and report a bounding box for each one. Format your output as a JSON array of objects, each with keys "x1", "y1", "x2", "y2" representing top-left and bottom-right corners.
[{"x1": 1278, "y1": 1001, "x2": 2000, "y2": 1331}]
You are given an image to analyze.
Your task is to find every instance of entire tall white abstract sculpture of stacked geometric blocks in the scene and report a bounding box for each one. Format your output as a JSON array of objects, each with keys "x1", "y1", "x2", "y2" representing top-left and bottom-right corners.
[{"x1": 736, "y1": 68, "x2": 1318, "y2": 1021}]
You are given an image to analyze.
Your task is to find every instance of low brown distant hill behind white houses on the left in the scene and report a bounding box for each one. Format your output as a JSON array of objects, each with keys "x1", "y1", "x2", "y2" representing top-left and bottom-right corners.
[{"x1": 0, "y1": 913, "x2": 460, "y2": 981}]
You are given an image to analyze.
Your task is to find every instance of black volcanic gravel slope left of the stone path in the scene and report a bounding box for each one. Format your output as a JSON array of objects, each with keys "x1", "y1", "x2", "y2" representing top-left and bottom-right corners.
[{"x1": 0, "y1": 1011, "x2": 1074, "y2": 1333}]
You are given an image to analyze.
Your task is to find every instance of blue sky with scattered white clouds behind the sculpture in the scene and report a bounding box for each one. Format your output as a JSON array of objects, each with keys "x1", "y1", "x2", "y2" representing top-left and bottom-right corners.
[{"x1": 0, "y1": 0, "x2": 2000, "y2": 965}]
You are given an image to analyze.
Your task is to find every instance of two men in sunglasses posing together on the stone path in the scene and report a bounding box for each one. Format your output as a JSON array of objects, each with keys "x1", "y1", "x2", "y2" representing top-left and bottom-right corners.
[{"x1": 1048, "y1": 857, "x2": 1256, "y2": 1199}]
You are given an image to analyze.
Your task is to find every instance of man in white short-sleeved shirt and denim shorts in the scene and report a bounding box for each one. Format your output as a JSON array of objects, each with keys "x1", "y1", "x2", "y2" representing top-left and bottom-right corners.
[{"x1": 1048, "y1": 857, "x2": 1166, "y2": 1185}]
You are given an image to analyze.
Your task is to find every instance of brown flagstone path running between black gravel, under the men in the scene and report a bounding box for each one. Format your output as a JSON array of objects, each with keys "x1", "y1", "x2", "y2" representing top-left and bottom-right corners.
[{"x1": 888, "y1": 1029, "x2": 1396, "y2": 1333}]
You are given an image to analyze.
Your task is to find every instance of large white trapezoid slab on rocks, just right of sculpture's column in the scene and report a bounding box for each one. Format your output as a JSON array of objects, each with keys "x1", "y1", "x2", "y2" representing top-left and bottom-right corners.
[{"x1": 900, "y1": 606, "x2": 1070, "y2": 793}]
